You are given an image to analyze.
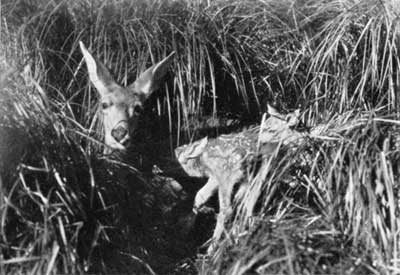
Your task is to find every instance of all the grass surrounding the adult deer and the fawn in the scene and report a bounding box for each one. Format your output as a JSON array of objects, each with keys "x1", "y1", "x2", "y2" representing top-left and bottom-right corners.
[{"x1": 0, "y1": 0, "x2": 400, "y2": 275}]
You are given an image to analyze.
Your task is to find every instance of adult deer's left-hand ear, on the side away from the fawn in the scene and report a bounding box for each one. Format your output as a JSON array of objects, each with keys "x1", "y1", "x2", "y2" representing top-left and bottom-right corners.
[{"x1": 79, "y1": 41, "x2": 116, "y2": 96}]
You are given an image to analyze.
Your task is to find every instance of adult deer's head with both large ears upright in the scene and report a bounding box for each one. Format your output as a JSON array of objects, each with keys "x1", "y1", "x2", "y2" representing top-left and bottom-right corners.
[{"x1": 79, "y1": 41, "x2": 175, "y2": 153}]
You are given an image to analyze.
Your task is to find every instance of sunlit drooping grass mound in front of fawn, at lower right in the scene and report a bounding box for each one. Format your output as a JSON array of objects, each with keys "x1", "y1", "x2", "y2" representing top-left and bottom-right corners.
[{"x1": 206, "y1": 111, "x2": 399, "y2": 274}]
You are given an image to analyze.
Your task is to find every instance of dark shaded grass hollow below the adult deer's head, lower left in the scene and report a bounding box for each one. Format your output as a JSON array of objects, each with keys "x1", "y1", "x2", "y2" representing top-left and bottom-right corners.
[{"x1": 2, "y1": 122, "x2": 214, "y2": 274}]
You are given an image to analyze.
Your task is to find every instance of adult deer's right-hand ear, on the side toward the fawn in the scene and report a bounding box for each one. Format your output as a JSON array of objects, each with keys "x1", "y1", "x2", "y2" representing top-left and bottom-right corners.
[{"x1": 129, "y1": 52, "x2": 175, "y2": 98}]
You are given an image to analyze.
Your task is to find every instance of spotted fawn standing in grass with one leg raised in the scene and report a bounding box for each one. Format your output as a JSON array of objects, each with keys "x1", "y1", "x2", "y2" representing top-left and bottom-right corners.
[{"x1": 175, "y1": 106, "x2": 303, "y2": 252}]
